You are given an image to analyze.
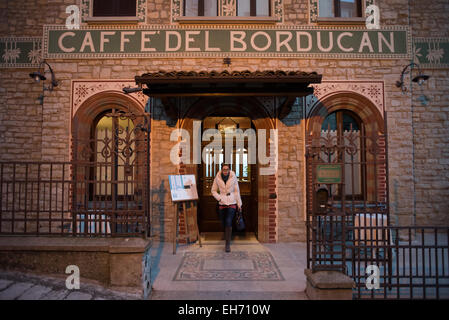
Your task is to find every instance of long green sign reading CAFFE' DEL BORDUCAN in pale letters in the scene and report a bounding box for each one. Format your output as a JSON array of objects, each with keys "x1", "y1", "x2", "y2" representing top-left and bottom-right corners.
[{"x1": 43, "y1": 25, "x2": 411, "y2": 59}]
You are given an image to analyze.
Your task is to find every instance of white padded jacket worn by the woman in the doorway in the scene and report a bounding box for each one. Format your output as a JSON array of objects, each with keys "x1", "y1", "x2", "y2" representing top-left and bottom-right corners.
[{"x1": 212, "y1": 170, "x2": 242, "y2": 207}]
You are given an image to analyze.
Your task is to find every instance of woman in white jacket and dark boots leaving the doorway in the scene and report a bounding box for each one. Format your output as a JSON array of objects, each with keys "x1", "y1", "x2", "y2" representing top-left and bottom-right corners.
[{"x1": 212, "y1": 164, "x2": 242, "y2": 252}]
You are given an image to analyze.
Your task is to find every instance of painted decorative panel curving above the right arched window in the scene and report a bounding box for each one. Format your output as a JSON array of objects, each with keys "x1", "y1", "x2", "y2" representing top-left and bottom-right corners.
[{"x1": 306, "y1": 81, "x2": 385, "y2": 116}]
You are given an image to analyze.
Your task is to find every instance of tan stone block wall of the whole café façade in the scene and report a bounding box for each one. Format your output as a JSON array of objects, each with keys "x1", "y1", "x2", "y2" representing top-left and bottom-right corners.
[{"x1": 0, "y1": 0, "x2": 449, "y2": 241}]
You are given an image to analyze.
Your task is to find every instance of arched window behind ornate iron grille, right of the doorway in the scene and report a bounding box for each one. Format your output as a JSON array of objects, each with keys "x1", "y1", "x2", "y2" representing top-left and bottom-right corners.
[{"x1": 321, "y1": 110, "x2": 366, "y2": 200}]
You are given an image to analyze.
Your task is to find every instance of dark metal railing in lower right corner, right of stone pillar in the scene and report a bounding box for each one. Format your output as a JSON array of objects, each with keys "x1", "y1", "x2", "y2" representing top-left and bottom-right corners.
[{"x1": 345, "y1": 226, "x2": 449, "y2": 299}]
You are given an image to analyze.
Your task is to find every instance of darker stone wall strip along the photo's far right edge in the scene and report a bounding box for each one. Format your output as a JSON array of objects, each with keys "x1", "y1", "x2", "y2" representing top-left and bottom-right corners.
[{"x1": 408, "y1": 0, "x2": 449, "y2": 225}]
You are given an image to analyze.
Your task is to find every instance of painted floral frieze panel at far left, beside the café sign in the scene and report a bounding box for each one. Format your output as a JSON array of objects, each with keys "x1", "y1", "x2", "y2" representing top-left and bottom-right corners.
[{"x1": 0, "y1": 37, "x2": 42, "y2": 68}]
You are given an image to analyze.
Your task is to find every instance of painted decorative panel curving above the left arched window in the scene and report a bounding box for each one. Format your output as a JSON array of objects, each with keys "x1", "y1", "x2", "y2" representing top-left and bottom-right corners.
[{"x1": 72, "y1": 80, "x2": 148, "y2": 117}]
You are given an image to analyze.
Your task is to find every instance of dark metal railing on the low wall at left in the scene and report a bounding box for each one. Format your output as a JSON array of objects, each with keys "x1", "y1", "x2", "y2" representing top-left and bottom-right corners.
[{"x1": 0, "y1": 162, "x2": 149, "y2": 237}]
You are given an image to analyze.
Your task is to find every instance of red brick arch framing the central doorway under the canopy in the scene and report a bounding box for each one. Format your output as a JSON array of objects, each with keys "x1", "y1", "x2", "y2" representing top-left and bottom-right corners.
[{"x1": 178, "y1": 97, "x2": 278, "y2": 242}]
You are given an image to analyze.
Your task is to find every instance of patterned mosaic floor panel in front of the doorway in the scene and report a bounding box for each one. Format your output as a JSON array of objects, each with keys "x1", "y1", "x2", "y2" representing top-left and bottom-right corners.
[{"x1": 173, "y1": 251, "x2": 285, "y2": 281}]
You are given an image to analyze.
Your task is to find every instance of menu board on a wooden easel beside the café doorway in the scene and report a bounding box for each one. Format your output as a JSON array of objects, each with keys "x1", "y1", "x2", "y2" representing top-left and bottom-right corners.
[{"x1": 168, "y1": 174, "x2": 202, "y2": 254}]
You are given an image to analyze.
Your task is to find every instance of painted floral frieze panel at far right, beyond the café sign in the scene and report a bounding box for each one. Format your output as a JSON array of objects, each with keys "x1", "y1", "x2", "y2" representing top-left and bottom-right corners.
[{"x1": 413, "y1": 38, "x2": 449, "y2": 69}]
